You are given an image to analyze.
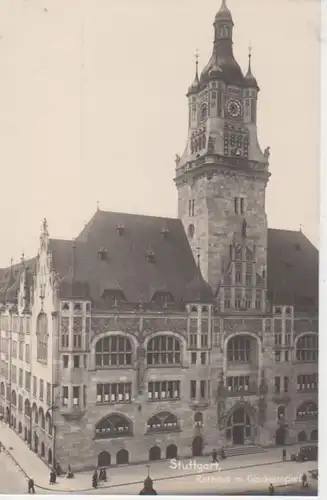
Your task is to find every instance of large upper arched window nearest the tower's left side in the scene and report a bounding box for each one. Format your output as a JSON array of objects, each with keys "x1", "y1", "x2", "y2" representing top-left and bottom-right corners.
[{"x1": 147, "y1": 335, "x2": 181, "y2": 365}]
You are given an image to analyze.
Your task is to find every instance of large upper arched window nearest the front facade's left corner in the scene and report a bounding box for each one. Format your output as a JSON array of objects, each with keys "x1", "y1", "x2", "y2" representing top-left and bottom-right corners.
[{"x1": 95, "y1": 335, "x2": 133, "y2": 368}]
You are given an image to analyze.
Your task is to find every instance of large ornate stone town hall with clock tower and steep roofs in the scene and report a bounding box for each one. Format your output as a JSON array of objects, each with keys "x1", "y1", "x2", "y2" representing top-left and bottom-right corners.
[{"x1": 0, "y1": 0, "x2": 318, "y2": 470}]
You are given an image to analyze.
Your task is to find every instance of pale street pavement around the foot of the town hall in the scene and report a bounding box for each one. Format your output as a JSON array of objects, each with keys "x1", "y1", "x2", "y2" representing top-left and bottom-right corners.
[{"x1": 0, "y1": 424, "x2": 316, "y2": 494}]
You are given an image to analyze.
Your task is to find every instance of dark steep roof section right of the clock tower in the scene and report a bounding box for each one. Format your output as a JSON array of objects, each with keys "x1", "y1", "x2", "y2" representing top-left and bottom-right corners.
[{"x1": 267, "y1": 229, "x2": 319, "y2": 310}]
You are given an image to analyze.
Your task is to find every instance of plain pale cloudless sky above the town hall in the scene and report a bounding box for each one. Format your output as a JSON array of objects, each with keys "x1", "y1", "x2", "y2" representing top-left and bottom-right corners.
[{"x1": 0, "y1": 0, "x2": 323, "y2": 267}]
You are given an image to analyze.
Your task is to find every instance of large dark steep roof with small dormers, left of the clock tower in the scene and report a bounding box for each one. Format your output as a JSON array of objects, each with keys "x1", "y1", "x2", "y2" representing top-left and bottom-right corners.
[{"x1": 50, "y1": 210, "x2": 196, "y2": 304}]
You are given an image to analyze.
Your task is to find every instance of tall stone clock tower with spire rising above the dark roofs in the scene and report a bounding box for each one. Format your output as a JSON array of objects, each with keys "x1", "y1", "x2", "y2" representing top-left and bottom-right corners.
[{"x1": 175, "y1": 0, "x2": 270, "y2": 293}]
